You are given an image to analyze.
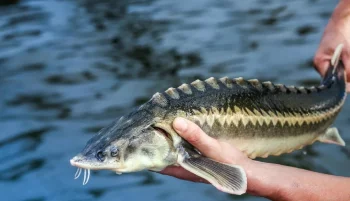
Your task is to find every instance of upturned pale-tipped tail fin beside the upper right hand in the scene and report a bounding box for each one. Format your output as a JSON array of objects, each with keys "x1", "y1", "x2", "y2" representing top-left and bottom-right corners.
[{"x1": 322, "y1": 44, "x2": 346, "y2": 87}]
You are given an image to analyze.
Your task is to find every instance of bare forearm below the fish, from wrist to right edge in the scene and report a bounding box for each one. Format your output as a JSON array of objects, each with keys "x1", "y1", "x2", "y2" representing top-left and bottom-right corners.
[{"x1": 244, "y1": 161, "x2": 350, "y2": 201}]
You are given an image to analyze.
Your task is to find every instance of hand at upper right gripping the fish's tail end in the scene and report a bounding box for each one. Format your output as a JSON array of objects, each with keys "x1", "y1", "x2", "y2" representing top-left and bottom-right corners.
[{"x1": 314, "y1": 0, "x2": 350, "y2": 92}]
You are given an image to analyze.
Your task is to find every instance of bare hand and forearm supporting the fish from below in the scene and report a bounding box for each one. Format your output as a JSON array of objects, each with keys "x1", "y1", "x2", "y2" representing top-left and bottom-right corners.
[{"x1": 161, "y1": 118, "x2": 350, "y2": 201}]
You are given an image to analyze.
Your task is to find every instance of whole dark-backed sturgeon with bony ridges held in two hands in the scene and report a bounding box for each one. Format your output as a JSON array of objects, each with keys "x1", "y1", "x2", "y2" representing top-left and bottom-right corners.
[{"x1": 70, "y1": 45, "x2": 346, "y2": 194}]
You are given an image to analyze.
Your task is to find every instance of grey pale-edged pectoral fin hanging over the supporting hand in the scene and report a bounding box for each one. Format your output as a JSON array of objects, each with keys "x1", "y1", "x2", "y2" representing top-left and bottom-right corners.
[{"x1": 178, "y1": 149, "x2": 247, "y2": 195}]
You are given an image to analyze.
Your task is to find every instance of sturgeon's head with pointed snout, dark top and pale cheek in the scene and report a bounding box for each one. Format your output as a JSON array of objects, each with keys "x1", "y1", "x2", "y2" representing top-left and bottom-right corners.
[{"x1": 70, "y1": 106, "x2": 176, "y2": 173}]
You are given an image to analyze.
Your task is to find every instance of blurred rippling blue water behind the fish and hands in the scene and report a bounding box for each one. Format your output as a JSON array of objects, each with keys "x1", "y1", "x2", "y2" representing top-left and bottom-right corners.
[{"x1": 0, "y1": 0, "x2": 350, "y2": 201}]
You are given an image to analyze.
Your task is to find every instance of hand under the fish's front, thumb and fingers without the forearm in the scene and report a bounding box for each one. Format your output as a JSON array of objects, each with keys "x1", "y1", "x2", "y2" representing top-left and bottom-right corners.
[{"x1": 160, "y1": 118, "x2": 252, "y2": 183}]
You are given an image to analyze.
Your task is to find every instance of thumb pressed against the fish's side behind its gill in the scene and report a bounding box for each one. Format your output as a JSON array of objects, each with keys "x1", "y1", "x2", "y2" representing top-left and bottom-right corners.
[{"x1": 173, "y1": 117, "x2": 221, "y2": 158}]
